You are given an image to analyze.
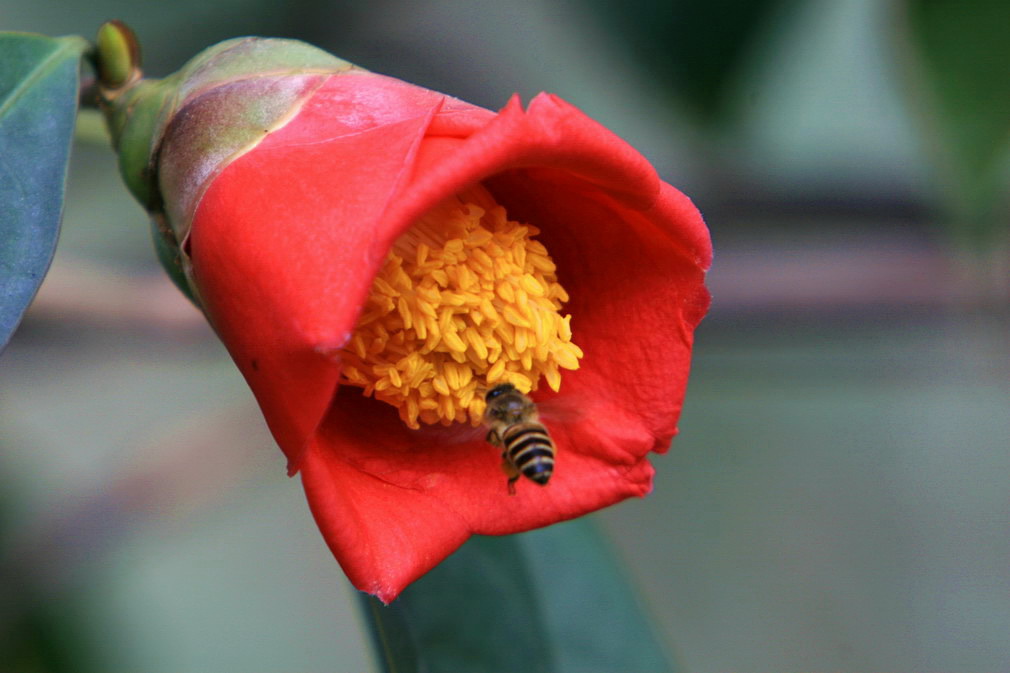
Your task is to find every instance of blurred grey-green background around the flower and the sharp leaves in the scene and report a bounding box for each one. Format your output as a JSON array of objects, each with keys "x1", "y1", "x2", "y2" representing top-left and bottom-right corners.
[{"x1": 0, "y1": 0, "x2": 1010, "y2": 673}]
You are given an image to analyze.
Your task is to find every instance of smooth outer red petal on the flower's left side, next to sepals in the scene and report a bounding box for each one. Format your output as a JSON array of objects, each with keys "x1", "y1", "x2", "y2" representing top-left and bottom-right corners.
[{"x1": 187, "y1": 74, "x2": 487, "y2": 472}]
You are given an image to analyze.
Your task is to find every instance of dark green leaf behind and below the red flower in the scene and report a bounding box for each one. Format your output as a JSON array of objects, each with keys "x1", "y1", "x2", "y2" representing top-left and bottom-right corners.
[{"x1": 364, "y1": 518, "x2": 676, "y2": 673}]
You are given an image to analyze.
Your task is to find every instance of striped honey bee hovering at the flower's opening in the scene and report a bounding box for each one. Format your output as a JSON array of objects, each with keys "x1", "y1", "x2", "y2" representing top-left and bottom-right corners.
[{"x1": 484, "y1": 383, "x2": 554, "y2": 495}]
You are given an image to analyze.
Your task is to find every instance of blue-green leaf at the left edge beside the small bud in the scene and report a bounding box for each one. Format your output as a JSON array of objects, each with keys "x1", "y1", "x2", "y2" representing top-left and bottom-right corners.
[{"x1": 0, "y1": 32, "x2": 88, "y2": 349}]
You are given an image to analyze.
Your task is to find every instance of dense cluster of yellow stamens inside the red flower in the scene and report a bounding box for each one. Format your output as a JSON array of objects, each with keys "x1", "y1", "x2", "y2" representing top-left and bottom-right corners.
[{"x1": 341, "y1": 186, "x2": 583, "y2": 428}]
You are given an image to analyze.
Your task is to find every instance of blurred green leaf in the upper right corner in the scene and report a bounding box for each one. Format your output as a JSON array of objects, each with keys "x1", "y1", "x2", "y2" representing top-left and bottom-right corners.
[{"x1": 903, "y1": 0, "x2": 1010, "y2": 248}]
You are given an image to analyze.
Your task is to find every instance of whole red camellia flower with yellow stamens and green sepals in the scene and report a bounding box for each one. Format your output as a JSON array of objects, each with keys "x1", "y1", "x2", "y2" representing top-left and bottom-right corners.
[{"x1": 106, "y1": 31, "x2": 711, "y2": 601}]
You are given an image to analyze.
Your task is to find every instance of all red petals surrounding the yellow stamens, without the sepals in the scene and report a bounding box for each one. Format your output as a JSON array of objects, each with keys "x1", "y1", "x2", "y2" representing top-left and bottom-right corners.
[{"x1": 191, "y1": 75, "x2": 711, "y2": 600}]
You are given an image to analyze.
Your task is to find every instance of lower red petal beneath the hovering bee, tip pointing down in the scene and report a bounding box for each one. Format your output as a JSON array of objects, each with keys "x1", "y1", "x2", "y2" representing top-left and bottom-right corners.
[{"x1": 302, "y1": 389, "x2": 652, "y2": 602}]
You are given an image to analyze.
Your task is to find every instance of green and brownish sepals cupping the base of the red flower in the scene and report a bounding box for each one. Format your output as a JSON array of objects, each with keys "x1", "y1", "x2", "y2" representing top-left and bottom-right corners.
[{"x1": 96, "y1": 29, "x2": 355, "y2": 301}]
